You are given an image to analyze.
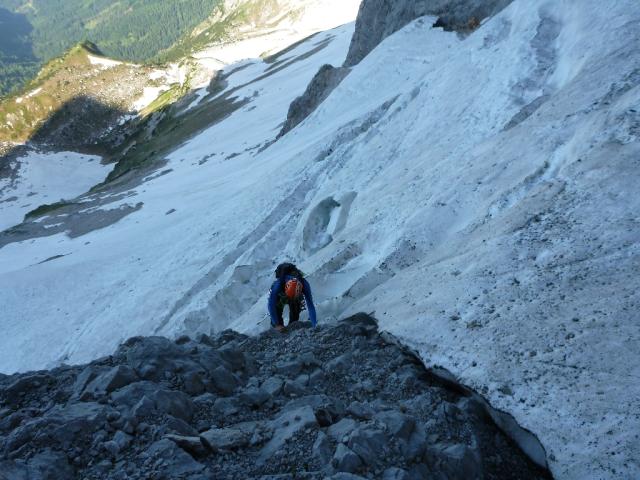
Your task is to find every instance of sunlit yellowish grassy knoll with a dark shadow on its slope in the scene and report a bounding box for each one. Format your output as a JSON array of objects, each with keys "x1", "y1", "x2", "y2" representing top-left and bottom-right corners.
[{"x1": 0, "y1": 42, "x2": 154, "y2": 144}]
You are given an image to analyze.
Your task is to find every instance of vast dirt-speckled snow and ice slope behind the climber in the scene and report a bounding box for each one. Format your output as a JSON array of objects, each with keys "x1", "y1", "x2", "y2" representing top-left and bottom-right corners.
[{"x1": 0, "y1": 0, "x2": 640, "y2": 479}]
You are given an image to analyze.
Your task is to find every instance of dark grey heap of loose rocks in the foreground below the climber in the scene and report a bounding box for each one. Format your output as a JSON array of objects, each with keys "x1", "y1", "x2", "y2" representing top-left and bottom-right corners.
[{"x1": 0, "y1": 314, "x2": 550, "y2": 480}]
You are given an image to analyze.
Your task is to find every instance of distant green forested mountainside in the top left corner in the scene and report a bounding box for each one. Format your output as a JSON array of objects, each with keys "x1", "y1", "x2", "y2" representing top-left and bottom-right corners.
[{"x1": 0, "y1": 0, "x2": 220, "y2": 95}]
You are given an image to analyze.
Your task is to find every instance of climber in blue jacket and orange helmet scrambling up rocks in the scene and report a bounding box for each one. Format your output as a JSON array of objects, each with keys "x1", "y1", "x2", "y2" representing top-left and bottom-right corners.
[{"x1": 269, "y1": 263, "x2": 316, "y2": 330}]
